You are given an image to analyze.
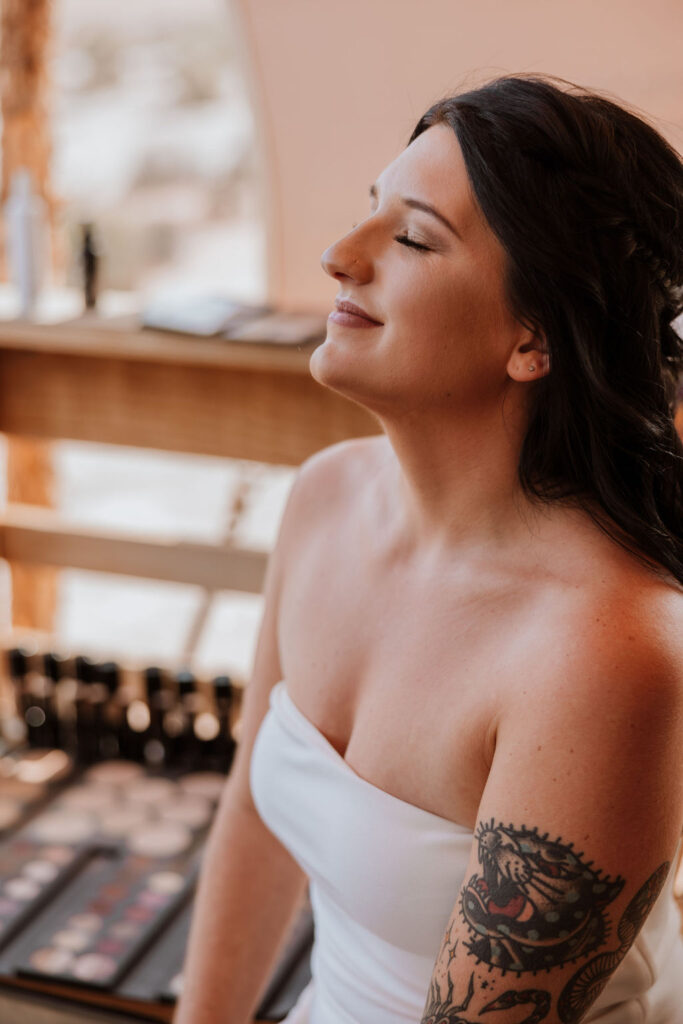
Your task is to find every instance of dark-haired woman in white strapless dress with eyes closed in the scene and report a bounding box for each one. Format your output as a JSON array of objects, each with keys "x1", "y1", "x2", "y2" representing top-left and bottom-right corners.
[{"x1": 177, "y1": 75, "x2": 683, "y2": 1024}]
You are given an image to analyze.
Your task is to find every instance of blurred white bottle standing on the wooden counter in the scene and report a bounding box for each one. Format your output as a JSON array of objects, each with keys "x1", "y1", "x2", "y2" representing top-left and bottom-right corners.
[{"x1": 5, "y1": 169, "x2": 47, "y2": 317}]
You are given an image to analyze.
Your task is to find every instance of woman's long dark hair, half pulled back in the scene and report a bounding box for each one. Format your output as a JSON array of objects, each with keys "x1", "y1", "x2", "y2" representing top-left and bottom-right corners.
[{"x1": 409, "y1": 73, "x2": 683, "y2": 584}]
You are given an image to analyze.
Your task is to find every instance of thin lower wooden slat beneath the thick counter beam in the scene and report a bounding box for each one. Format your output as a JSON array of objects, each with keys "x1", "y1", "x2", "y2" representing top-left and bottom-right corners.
[{"x1": 0, "y1": 504, "x2": 268, "y2": 594}]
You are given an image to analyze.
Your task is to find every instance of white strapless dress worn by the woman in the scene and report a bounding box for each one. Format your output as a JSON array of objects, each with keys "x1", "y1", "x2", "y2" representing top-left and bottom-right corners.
[{"x1": 250, "y1": 680, "x2": 683, "y2": 1024}]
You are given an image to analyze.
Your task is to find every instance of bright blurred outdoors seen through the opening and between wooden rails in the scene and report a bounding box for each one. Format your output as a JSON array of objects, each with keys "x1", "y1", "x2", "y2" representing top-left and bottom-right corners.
[{"x1": 0, "y1": 0, "x2": 288, "y2": 678}]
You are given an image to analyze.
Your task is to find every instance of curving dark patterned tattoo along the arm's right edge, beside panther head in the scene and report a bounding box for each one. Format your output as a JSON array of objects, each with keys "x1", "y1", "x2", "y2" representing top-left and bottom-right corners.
[{"x1": 557, "y1": 861, "x2": 670, "y2": 1024}]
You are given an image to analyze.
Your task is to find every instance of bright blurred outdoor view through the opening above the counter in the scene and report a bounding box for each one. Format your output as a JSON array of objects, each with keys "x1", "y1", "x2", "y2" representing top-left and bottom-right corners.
[{"x1": 51, "y1": 0, "x2": 264, "y2": 299}]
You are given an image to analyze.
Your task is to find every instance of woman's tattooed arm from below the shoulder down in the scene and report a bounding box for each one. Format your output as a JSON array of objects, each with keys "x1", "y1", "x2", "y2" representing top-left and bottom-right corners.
[{"x1": 424, "y1": 630, "x2": 683, "y2": 1024}]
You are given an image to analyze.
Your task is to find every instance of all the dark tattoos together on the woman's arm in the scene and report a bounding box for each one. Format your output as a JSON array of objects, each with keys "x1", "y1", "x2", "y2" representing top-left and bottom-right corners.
[{"x1": 422, "y1": 819, "x2": 670, "y2": 1024}]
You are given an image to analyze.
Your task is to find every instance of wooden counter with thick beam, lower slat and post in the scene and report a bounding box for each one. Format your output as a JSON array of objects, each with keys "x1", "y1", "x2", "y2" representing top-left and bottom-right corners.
[{"x1": 0, "y1": 314, "x2": 379, "y2": 632}]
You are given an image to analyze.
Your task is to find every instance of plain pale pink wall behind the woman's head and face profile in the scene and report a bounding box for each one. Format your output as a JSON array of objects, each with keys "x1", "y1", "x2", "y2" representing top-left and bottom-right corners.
[{"x1": 231, "y1": 0, "x2": 683, "y2": 312}]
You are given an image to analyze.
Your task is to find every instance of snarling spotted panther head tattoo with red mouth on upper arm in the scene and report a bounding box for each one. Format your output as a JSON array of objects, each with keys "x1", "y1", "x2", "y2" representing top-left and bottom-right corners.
[{"x1": 460, "y1": 819, "x2": 625, "y2": 974}]
